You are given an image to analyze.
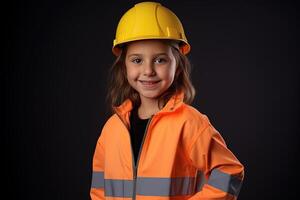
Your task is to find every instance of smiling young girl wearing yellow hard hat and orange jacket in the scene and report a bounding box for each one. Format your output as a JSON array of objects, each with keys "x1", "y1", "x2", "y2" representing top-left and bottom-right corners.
[{"x1": 90, "y1": 2, "x2": 244, "y2": 200}]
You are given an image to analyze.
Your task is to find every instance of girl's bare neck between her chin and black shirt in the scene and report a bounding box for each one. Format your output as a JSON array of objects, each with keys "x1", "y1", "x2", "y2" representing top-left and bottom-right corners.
[{"x1": 138, "y1": 97, "x2": 159, "y2": 119}]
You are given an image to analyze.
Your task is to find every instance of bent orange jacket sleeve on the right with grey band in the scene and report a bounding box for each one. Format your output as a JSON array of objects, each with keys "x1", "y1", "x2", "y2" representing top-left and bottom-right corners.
[{"x1": 189, "y1": 124, "x2": 244, "y2": 200}]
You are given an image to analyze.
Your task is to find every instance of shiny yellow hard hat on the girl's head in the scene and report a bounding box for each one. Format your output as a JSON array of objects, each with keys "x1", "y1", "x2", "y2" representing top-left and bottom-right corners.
[{"x1": 112, "y1": 2, "x2": 191, "y2": 55}]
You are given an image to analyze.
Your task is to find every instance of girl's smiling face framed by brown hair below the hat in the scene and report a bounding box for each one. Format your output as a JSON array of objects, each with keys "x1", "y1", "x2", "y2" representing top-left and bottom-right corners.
[{"x1": 125, "y1": 40, "x2": 176, "y2": 101}]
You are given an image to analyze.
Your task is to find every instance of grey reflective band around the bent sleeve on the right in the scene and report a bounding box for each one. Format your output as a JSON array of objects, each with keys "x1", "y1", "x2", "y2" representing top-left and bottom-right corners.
[{"x1": 208, "y1": 169, "x2": 242, "y2": 196}]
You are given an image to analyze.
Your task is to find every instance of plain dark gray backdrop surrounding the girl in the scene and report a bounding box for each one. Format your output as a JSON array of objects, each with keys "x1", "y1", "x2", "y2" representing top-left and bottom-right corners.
[{"x1": 1, "y1": 0, "x2": 299, "y2": 200}]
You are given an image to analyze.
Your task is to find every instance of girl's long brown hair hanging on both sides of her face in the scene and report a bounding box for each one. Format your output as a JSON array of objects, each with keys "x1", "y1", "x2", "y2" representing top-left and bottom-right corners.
[{"x1": 107, "y1": 40, "x2": 195, "y2": 111}]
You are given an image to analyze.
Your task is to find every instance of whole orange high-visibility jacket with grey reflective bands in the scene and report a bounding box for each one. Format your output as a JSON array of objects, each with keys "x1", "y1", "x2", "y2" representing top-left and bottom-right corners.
[{"x1": 90, "y1": 94, "x2": 244, "y2": 200}]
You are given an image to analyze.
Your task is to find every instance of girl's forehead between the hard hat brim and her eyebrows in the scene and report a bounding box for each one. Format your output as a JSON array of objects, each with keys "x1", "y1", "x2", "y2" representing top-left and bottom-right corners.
[{"x1": 127, "y1": 40, "x2": 171, "y2": 54}]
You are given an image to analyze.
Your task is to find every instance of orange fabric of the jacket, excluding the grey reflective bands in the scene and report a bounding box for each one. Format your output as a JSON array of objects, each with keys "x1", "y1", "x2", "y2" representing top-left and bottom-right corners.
[{"x1": 91, "y1": 94, "x2": 244, "y2": 200}]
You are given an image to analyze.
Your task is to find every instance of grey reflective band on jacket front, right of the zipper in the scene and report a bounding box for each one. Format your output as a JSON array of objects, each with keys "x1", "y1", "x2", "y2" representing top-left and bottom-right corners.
[{"x1": 136, "y1": 177, "x2": 195, "y2": 196}]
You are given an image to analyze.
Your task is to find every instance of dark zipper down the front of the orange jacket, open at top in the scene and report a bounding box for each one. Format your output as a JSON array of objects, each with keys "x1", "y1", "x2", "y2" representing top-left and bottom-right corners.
[{"x1": 117, "y1": 114, "x2": 153, "y2": 200}]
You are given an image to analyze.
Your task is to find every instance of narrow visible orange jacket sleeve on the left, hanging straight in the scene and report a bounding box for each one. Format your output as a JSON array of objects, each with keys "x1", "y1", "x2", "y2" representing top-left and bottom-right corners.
[{"x1": 90, "y1": 134, "x2": 105, "y2": 200}]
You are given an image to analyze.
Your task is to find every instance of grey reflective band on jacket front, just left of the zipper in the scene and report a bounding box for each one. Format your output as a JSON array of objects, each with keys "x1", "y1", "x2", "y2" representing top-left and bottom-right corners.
[{"x1": 104, "y1": 179, "x2": 133, "y2": 197}]
